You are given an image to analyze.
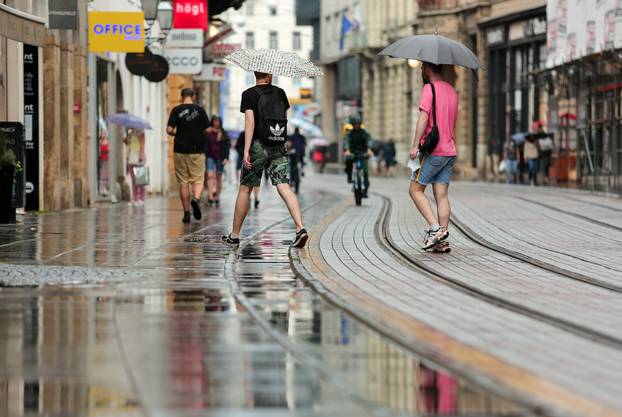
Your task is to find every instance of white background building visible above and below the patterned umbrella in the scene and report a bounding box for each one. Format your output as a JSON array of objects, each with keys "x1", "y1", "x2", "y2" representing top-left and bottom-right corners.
[{"x1": 222, "y1": 0, "x2": 313, "y2": 131}]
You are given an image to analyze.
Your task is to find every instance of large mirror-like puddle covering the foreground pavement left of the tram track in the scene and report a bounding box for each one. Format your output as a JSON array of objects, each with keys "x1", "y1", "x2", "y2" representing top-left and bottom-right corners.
[{"x1": 0, "y1": 193, "x2": 530, "y2": 417}]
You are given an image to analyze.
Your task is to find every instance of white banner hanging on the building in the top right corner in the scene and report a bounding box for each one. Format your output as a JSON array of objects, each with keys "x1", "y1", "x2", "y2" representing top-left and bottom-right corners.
[{"x1": 546, "y1": 0, "x2": 622, "y2": 68}]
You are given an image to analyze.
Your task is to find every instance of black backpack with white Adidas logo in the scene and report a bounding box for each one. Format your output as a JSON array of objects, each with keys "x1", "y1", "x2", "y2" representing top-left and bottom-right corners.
[{"x1": 254, "y1": 86, "x2": 287, "y2": 144}]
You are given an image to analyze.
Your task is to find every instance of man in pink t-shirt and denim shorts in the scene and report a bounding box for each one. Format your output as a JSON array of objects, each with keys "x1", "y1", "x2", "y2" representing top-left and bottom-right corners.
[{"x1": 410, "y1": 62, "x2": 458, "y2": 249}]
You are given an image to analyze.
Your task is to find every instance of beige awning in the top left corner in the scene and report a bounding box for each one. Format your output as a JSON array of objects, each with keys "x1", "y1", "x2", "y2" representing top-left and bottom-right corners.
[{"x1": 0, "y1": 3, "x2": 45, "y2": 46}]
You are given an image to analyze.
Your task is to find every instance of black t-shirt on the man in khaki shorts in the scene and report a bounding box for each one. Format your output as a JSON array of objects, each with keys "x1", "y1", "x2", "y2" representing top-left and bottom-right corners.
[{"x1": 168, "y1": 104, "x2": 210, "y2": 154}]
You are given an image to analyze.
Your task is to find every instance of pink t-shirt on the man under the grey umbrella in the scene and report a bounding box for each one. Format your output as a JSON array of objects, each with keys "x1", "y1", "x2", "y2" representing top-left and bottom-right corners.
[{"x1": 419, "y1": 81, "x2": 458, "y2": 156}]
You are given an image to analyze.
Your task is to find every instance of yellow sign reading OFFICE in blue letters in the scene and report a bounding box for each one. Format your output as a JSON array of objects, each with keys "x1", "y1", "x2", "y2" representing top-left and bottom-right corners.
[{"x1": 89, "y1": 12, "x2": 145, "y2": 52}]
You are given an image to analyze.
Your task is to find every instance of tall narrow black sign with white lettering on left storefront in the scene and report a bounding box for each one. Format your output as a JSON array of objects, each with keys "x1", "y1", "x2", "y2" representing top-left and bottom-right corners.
[{"x1": 23, "y1": 45, "x2": 40, "y2": 211}]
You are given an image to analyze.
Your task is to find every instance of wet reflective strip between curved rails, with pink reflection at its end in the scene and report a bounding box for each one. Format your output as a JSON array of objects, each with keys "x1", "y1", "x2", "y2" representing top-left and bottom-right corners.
[{"x1": 236, "y1": 228, "x2": 528, "y2": 416}]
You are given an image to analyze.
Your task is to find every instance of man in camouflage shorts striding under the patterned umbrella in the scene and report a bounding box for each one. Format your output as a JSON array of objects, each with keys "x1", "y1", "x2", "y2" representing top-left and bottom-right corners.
[{"x1": 222, "y1": 72, "x2": 309, "y2": 248}]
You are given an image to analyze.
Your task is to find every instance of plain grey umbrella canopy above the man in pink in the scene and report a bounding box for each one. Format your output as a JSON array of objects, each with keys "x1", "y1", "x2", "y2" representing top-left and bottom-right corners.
[{"x1": 378, "y1": 35, "x2": 482, "y2": 70}]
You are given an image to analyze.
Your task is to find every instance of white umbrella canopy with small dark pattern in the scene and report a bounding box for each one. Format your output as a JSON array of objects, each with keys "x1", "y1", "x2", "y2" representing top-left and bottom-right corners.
[{"x1": 225, "y1": 49, "x2": 324, "y2": 78}]
